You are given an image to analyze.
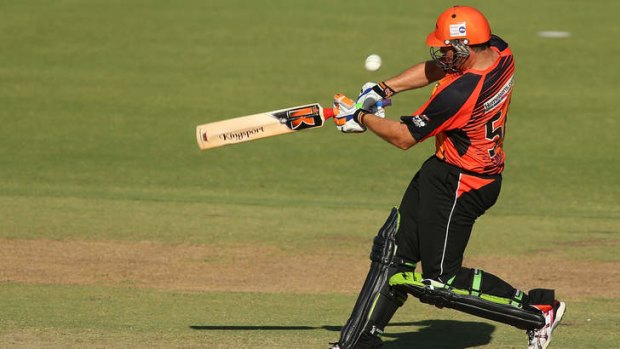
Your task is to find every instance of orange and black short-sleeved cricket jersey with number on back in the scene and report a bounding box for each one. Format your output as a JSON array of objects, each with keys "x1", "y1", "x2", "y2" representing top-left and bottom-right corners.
[{"x1": 401, "y1": 36, "x2": 514, "y2": 175}]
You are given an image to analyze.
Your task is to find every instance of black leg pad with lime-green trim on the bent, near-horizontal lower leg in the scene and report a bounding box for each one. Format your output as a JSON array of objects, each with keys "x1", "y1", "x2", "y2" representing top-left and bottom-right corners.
[{"x1": 389, "y1": 272, "x2": 545, "y2": 330}]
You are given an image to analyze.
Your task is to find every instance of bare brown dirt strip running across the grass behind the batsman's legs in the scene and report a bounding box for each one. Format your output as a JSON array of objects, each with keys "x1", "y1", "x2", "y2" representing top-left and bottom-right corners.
[{"x1": 0, "y1": 239, "x2": 620, "y2": 297}]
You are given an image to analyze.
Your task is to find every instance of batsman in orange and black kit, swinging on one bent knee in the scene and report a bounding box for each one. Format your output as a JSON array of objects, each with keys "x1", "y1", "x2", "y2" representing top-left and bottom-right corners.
[{"x1": 331, "y1": 6, "x2": 566, "y2": 349}]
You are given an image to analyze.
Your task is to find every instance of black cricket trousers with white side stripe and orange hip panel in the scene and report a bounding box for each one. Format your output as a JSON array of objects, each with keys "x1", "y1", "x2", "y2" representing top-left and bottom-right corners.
[{"x1": 396, "y1": 156, "x2": 502, "y2": 283}]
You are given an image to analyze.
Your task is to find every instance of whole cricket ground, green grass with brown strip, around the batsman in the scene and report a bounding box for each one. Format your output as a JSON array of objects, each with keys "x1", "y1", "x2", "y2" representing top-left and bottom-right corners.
[{"x1": 0, "y1": 0, "x2": 620, "y2": 349}]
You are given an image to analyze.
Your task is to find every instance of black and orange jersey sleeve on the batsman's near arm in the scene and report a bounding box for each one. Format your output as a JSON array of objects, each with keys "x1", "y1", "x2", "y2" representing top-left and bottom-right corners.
[{"x1": 400, "y1": 73, "x2": 481, "y2": 142}]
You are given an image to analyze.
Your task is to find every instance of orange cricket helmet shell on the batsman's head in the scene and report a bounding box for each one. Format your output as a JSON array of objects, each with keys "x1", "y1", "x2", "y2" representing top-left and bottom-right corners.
[{"x1": 426, "y1": 6, "x2": 491, "y2": 47}]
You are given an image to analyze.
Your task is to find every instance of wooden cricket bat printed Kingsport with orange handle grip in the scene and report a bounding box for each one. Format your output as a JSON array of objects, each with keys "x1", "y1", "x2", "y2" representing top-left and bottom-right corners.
[{"x1": 196, "y1": 99, "x2": 391, "y2": 150}]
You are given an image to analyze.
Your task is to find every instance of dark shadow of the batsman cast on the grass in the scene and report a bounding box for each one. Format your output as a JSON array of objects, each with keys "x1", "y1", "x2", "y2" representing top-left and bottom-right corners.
[{"x1": 190, "y1": 320, "x2": 495, "y2": 349}]
